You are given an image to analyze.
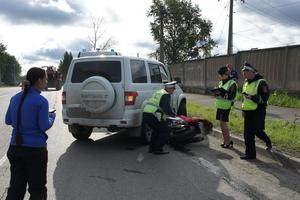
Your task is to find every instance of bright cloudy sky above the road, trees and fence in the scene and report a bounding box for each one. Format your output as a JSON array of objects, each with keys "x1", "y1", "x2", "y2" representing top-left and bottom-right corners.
[{"x1": 0, "y1": 0, "x2": 300, "y2": 73}]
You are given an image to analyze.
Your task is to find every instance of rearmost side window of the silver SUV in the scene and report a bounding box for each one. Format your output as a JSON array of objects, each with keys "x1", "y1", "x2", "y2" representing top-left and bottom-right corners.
[{"x1": 130, "y1": 60, "x2": 147, "y2": 83}]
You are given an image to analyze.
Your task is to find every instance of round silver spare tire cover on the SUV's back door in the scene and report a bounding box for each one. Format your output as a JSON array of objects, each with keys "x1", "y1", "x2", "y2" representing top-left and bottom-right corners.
[{"x1": 80, "y1": 76, "x2": 115, "y2": 113}]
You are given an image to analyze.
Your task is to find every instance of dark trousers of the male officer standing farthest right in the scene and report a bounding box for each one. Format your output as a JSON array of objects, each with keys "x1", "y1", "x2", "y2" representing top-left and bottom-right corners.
[{"x1": 244, "y1": 109, "x2": 271, "y2": 157}]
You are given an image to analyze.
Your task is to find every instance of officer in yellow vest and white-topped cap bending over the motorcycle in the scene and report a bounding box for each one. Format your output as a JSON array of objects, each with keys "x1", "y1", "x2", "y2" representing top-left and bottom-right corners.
[{"x1": 143, "y1": 81, "x2": 176, "y2": 155}]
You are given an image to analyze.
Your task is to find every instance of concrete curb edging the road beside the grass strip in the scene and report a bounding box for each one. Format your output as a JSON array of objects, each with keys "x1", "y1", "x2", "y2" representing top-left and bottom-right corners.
[{"x1": 210, "y1": 128, "x2": 300, "y2": 174}]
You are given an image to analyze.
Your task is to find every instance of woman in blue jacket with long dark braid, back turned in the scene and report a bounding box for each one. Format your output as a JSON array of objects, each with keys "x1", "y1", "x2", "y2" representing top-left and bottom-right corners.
[{"x1": 5, "y1": 67, "x2": 56, "y2": 200}]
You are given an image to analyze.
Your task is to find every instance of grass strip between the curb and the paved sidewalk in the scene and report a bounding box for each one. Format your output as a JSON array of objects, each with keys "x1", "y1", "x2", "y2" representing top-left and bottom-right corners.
[{"x1": 187, "y1": 103, "x2": 300, "y2": 157}]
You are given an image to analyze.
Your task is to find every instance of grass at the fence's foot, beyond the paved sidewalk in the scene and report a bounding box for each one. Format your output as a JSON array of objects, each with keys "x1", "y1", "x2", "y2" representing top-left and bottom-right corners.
[{"x1": 237, "y1": 90, "x2": 300, "y2": 108}]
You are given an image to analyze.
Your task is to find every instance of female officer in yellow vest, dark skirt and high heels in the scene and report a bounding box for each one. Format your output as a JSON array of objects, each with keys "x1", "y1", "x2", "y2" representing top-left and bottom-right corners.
[{"x1": 214, "y1": 67, "x2": 238, "y2": 148}]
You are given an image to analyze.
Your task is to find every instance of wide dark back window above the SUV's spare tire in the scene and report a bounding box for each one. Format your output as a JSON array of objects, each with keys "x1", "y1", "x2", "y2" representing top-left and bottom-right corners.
[{"x1": 71, "y1": 61, "x2": 121, "y2": 83}]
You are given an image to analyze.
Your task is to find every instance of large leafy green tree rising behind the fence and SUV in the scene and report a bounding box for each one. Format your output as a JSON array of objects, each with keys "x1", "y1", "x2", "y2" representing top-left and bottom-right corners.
[{"x1": 147, "y1": 0, "x2": 216, "y2": 63}]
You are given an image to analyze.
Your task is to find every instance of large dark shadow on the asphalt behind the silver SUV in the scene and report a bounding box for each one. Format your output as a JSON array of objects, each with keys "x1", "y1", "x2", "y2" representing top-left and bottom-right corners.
[{"x1": 53, "y1": 135, "x2": 237, "y2": 200}]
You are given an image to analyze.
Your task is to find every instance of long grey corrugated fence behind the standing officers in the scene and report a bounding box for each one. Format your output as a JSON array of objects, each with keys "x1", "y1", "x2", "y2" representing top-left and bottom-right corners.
[{"x1": 170, "y1": 45, "x2": 300, "y2": 93}]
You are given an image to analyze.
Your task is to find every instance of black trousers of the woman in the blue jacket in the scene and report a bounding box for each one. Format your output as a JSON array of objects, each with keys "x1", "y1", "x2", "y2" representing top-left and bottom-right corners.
[{"x1": 6, "y1": 146, "x2": 48, "y2": 200}]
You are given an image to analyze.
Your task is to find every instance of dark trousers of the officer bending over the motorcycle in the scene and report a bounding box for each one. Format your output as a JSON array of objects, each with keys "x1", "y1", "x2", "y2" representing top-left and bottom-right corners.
[{"x1": 143, "y1": 113, "x2": 169, "y2": 151}]
